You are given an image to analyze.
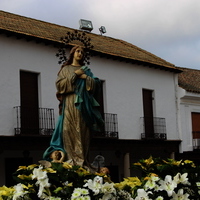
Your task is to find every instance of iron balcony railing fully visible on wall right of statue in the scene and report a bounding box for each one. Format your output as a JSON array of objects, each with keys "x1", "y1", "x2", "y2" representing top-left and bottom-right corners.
[{"x1": 140, "y1": 117, "x2": 167, "y2": 140}]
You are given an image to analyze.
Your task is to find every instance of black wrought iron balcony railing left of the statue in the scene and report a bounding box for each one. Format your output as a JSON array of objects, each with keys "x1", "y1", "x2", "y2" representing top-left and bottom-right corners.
[{"x1": 14, "y1": 106, "x2": 55, "y2": 135}]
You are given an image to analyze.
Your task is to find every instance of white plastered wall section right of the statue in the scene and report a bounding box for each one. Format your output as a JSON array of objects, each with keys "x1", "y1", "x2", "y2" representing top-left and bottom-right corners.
[{"x1": 90, "y1": 57, "x2": 179, "y2": 140}]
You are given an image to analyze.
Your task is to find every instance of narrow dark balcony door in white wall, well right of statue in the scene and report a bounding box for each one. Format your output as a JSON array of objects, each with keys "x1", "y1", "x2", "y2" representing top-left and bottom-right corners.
[{"x1": 142, "y1": 89, "x2": 154, "y2": 138}]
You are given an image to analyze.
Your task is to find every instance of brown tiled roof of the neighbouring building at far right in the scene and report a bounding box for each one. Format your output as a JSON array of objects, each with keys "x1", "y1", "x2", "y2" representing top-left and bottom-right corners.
[{"x1": 178, "y1": 68, "x2": 200, "y2": 93}]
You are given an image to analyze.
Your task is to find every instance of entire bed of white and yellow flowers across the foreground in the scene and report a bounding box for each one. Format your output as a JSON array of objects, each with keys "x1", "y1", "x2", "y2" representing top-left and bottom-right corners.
[{"x1": 0, "y1": 157, "x2": 200, "y2": 200}]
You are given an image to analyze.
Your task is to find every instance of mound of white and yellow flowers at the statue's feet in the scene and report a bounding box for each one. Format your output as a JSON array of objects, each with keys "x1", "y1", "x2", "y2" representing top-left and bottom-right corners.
[{"x1": 0, "y1": 162, "x2": 131, "y2": 200}]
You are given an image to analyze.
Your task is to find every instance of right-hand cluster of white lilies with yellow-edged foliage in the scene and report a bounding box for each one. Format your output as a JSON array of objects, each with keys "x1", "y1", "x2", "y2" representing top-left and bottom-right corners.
[{"x1": 133, "y1": 157, "x2": 200, "y2": 200}]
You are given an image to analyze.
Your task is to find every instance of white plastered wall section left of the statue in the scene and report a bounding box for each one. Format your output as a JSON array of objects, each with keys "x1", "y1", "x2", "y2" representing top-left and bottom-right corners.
[{"x1": 0, "y1": 35, "x2": 60, "y2": 135}]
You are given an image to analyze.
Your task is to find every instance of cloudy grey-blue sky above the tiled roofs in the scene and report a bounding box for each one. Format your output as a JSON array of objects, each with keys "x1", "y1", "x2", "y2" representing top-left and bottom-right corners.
[{"x1": 0, "y1": 0, "x2": 200, "y2": 70}]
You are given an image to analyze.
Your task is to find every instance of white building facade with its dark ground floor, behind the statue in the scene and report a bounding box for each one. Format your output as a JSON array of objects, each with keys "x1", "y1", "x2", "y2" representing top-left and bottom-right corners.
[{"x1": 0, "y1": 10, "x2": 183, "y2": 185}]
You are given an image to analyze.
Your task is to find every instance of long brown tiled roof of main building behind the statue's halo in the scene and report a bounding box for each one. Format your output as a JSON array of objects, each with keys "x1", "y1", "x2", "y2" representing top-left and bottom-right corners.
[{"x1": 0, "y1": 11, "x2": 179, "y2": 72}]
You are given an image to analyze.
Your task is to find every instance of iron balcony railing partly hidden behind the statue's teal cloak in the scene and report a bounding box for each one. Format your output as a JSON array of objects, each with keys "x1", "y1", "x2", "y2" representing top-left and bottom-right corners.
[{"x1": 92, "y1": 113, "x2": 118, "y2": 139}]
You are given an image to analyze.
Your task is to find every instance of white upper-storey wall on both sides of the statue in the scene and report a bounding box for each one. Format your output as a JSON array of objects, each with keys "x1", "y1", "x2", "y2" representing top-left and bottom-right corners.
[{"x1": 0, "y1": 35, "x2": 179, "y2": 140}]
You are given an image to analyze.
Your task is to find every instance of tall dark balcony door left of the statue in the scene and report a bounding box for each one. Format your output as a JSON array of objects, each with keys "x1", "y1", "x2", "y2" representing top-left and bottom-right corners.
[{"x1": 20, "y1": 71, "x2": 39, "y2": 135}]
